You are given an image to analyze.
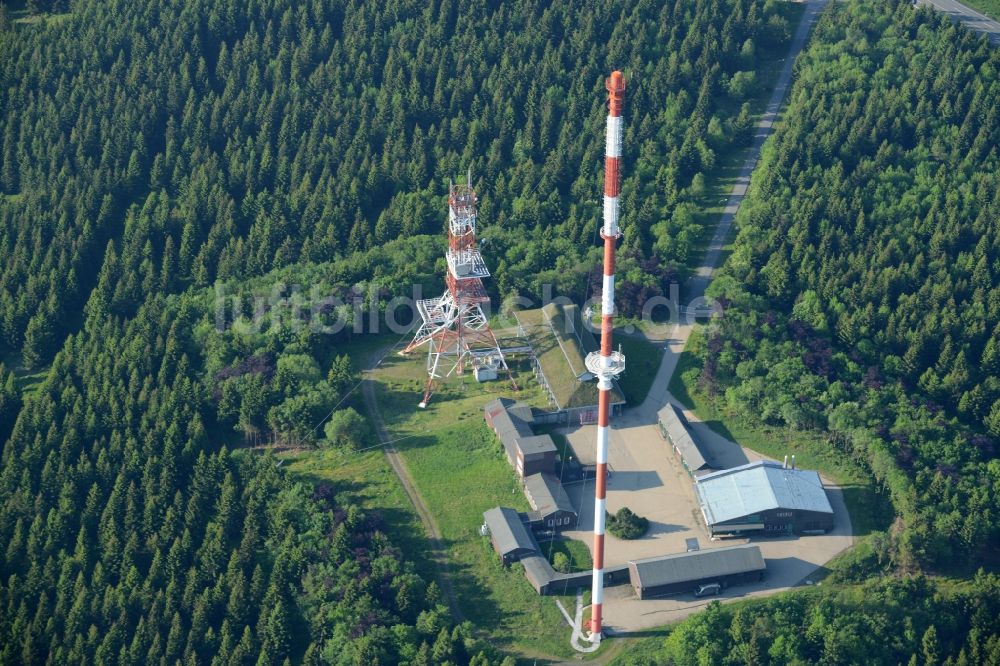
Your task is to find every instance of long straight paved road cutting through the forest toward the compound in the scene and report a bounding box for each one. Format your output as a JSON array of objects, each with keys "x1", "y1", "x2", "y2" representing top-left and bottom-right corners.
[{"x1": 687, "y1": 0, "x2": 828, "y2": 299}]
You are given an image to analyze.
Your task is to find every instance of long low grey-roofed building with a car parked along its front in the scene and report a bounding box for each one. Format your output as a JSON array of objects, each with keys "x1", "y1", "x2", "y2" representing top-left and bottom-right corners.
[{"x1": 628, "y1": 545, "x2": 766, "y2": 599}]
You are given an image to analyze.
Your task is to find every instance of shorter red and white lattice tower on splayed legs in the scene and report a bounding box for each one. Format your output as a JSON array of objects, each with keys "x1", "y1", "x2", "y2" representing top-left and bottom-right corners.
[{"x1": 402, "y1": 170, "x2": 517, "y2": 407}]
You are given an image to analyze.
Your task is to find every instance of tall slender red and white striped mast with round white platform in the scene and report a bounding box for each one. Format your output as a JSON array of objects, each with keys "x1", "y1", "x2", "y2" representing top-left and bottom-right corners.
[{"x1": 587, "y1": 71, "x2": 625, "y2": 643}]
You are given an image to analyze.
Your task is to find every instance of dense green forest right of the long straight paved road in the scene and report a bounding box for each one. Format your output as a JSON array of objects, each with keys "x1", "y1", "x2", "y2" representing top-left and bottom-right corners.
[{"x1": 701, "y1": 3, "x2": 1000, "y2": 570}]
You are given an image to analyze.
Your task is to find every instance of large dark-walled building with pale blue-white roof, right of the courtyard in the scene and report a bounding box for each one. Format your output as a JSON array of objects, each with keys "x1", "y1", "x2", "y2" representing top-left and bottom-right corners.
[{"x1": 695, "y1": 460, "x2": 833, "y2": 536}]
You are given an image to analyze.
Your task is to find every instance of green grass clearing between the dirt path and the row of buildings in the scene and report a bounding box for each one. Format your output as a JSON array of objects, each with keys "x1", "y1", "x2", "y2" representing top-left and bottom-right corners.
[{"x1": 372, "y1": 356, "x2": 600, "y2": 659}]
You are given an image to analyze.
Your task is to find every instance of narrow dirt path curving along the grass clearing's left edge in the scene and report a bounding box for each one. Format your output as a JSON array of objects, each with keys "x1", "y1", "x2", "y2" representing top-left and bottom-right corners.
[{"x1": 361, "y1": 348, "x2": 465, "y2": 622}]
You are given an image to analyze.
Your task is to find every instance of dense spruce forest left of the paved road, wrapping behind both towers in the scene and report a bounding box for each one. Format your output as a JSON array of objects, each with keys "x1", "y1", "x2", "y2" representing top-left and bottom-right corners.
[{"x1": 0, "y1": 0, "x2": 789, "y2": 664}]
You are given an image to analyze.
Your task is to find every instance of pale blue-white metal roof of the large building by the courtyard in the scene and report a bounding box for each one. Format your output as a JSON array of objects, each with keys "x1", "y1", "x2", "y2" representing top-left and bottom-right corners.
[{"x1": 695, "y1": 460, "x2": 833, "y2": 525}]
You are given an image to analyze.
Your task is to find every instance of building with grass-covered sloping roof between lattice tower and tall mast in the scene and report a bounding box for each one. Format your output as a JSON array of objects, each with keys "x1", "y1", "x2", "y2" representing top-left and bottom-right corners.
[{"x1": 514, "y1": 303, "x2": 625, "y2": 423}]
